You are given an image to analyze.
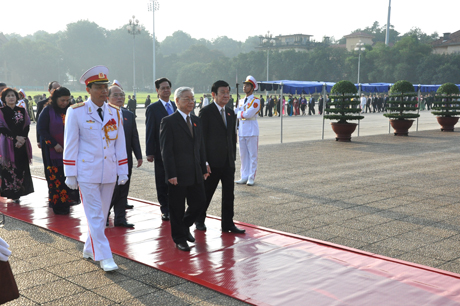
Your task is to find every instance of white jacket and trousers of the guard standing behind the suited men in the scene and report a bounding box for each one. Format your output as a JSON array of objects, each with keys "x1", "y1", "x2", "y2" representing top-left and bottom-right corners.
[{"x1": 235, "y1": 95, "x2": 260, "y2": 180}]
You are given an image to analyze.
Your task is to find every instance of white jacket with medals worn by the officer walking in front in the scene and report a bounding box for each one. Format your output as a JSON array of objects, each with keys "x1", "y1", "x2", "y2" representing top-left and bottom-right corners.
[{"x1": 64, "y1": 99, "x2": 128, "y2": 184}]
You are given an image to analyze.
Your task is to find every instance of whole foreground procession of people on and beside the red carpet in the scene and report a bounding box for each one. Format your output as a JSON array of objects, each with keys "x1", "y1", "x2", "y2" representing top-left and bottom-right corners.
[{"x1": 0, "y1": 66, "x2": 261, "y2": 271}]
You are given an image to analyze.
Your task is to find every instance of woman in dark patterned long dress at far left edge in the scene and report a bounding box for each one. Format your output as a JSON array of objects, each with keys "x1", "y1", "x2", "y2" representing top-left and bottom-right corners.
[{"x1": 0, "y1": 88, "x2": 34, "y2": 204}]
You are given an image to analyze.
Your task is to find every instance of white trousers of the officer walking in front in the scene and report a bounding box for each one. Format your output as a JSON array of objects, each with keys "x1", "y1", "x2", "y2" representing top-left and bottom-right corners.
[{"x1": 78, "y1": 182, "x2": 115, "y2": 261}]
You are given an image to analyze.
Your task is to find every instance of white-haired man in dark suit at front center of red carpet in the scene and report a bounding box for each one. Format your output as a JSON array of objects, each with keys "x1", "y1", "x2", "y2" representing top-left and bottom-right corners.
[{"x1": 160, "y1": 87, "x2": 209, "y2": 251}]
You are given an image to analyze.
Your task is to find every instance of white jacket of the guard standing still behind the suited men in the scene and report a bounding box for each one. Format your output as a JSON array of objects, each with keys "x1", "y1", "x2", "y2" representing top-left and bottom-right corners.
[{"x1": 235, "y1": 95, "x2": 260, "y2": 137}]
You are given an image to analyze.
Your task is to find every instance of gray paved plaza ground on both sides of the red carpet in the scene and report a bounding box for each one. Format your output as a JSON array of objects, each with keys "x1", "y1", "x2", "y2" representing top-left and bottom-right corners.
[{"x1": 0, "y1": 110, "x2": 460, "y2": 305}]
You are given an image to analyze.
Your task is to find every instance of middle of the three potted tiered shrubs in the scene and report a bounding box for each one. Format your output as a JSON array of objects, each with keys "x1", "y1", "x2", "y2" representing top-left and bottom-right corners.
[{"x1": 383, "y1": 81, "x2": 420, "y2": 136}]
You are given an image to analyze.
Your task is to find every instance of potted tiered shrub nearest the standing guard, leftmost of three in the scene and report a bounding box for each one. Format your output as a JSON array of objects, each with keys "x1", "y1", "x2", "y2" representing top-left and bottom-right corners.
[{"x1": 324, "y1": 80, "x2": 364, "y2": 141}]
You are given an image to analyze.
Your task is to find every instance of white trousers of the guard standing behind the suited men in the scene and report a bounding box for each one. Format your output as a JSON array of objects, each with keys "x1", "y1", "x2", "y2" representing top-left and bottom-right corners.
[{"x1": 238, "y1": 136, "x2": 259, "y2": 180}]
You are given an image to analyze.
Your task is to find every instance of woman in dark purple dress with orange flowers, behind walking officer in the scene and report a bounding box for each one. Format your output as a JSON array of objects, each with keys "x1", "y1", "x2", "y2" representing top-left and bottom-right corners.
[{"x1": 37, "y1": 87, "x2": 80, "y2": 215}]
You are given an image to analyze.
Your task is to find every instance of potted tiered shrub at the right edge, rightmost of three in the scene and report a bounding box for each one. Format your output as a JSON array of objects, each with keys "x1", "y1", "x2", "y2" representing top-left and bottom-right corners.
[{"x1": 431, "y1": 83, "x2": 460, "y2": 132}]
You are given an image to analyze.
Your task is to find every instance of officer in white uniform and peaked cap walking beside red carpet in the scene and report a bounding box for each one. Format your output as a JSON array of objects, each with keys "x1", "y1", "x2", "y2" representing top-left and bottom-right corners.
[{"x1": 64, "y1": 66, "x2": 128, "y2": 271}]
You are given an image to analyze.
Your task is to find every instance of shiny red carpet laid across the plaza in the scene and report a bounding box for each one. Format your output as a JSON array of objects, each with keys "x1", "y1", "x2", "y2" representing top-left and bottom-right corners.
[{"x1": 0, "y1": 178, "x2": 460, "y2": 306}]
